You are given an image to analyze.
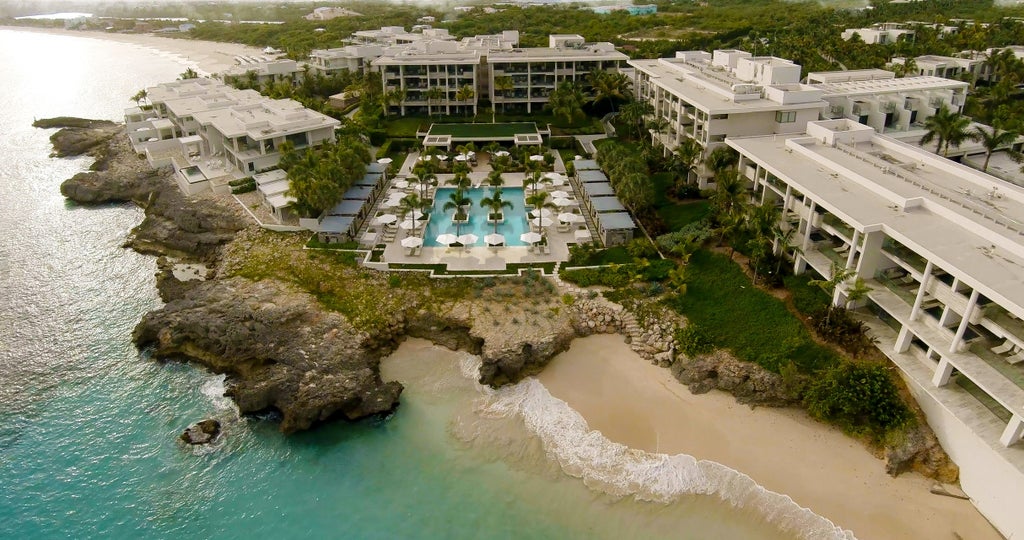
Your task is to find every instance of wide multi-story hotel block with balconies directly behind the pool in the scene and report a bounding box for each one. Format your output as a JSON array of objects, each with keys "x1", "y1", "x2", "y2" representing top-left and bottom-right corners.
[{"x1": 373, "y1": 31, "x2": 628, "y2": 115}]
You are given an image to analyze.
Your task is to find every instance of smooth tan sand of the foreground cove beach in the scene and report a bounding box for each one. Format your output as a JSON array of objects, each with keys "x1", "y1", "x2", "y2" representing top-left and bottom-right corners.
[{"x1": 538, "y1": 335, "x2": 1000, "y2": 540}]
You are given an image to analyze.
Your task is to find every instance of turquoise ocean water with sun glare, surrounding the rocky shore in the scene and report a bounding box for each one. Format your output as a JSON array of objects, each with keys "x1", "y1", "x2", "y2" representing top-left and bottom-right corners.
[{"x1": 0, "y1": 31, "x2": 842, "y2": 539}]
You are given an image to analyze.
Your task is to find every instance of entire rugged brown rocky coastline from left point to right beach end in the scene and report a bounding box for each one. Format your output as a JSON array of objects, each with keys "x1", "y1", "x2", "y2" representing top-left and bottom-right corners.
[{"x1": 44, "y1": 119, "x2": 955, "y2": 481}]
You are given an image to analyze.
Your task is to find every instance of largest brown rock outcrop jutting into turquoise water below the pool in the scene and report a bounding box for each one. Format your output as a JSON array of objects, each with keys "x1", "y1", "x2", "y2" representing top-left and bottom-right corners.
[{"x1": 133, "y1": 278, "x2": 401, "y2": 432}]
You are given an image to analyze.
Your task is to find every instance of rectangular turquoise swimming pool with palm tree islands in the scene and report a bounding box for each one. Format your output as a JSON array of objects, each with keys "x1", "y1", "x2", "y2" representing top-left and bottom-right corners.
[{"x1": 423, "y1": 188, "x2": 529, "y2": 247}]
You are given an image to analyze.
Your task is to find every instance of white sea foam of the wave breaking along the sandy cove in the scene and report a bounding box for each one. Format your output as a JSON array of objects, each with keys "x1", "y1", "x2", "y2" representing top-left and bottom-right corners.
[{"x1": 460, "y1": 355, "x2": 855, "y2": 540}]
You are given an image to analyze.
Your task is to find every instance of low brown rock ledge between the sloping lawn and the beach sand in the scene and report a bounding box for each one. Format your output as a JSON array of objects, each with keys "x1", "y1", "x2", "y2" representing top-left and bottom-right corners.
[{"x1": 672, "y1": 350, "x2": 800, "y2": 407}]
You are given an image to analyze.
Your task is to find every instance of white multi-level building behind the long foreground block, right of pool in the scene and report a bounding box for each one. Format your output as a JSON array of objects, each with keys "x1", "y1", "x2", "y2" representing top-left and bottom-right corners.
[{"x1": 630, "y1": 50, "x2": 969, "y2": 186}]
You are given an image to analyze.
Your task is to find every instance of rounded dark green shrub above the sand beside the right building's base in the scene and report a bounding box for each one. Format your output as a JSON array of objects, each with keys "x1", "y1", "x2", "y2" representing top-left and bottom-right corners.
[{"x1": 804, "y1": 362, "x2": 911, "y2": 440}]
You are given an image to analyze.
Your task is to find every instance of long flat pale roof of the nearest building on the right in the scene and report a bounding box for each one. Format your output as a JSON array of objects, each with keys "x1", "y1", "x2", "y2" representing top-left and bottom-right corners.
[{"x1": 726, "y1": 124, "x2": 1024, "y2": 314}]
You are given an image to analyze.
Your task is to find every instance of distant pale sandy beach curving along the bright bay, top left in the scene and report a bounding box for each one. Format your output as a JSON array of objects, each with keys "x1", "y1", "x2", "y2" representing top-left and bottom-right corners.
[{"x1": 0, "y1": 27, "x2": 262, "y2": 75}]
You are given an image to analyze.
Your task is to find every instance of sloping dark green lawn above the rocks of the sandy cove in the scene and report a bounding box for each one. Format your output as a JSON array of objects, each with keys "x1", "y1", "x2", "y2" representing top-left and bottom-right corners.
[{"x1": 670, "y1": 250, "x2": 839, "y2": 373}]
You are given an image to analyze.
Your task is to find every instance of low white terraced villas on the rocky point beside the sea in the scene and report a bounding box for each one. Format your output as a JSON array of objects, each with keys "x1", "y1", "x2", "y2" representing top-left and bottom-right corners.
[{"x1": 125, "y1": 79, "x2": 340, "y2": 194}]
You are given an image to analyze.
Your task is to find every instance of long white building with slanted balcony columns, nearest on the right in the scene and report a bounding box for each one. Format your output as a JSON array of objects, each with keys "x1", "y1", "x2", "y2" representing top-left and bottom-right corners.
[{"x1": 726, "y1": 119, "x2": 1024, "y2": 536}]
